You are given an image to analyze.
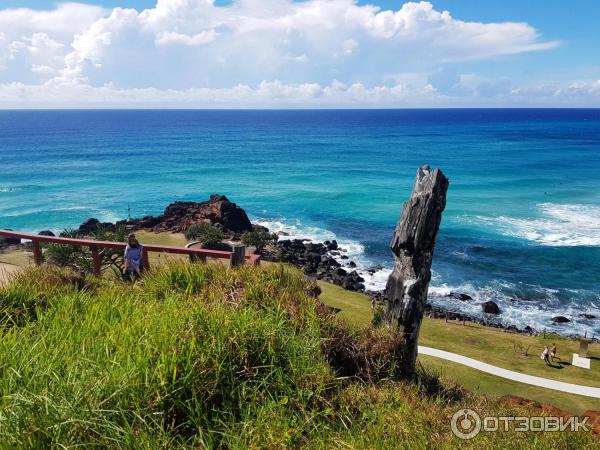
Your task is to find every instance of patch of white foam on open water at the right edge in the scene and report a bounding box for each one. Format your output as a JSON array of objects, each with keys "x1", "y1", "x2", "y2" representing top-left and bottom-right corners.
[{"x1": 477, "y1": 203, "x2": 600, "y2": 247}]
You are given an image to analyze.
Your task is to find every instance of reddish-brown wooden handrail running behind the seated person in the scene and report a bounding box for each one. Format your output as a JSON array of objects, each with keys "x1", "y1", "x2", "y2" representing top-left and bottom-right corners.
[{"x1": 0, "y1": 230, "x2": 260, "y2": 265}]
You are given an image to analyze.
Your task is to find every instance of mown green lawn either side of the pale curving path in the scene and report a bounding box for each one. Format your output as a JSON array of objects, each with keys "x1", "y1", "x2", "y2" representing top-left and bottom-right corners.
[{"x1": 319, "y1": 282, "x2": 600, "y2": 414}]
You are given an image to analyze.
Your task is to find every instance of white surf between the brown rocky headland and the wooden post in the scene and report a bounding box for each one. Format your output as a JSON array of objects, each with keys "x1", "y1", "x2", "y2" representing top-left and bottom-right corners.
[{"x1": 253, "y1": 219, "x2": 392, "y2": 291}]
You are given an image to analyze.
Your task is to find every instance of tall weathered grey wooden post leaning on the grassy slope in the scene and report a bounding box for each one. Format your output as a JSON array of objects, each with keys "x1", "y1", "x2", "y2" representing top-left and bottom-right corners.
[{"x1": 385, "y1": 165, "x2": 449, "y2": 378}]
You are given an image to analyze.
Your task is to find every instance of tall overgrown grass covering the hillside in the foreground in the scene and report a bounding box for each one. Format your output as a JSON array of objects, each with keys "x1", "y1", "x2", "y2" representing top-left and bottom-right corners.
[{"x1": 0, "y1": 264, "x2": 595, "y2": 449}]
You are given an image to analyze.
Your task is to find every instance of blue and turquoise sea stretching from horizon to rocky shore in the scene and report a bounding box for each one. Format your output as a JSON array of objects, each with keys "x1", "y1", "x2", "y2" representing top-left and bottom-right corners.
[{"x1": 0, "y1": 109, "x2": 600, "y2": 335}]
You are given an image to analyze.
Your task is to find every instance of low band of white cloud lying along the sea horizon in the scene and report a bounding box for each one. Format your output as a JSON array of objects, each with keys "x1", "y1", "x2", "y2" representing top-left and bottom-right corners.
[{"x1": 0, "y1": 78, "x2": 600, "y2": 108}]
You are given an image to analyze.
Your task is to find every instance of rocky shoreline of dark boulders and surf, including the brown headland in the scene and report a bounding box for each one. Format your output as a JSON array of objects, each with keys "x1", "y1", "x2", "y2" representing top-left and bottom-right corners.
[{"x1": 0, "y1": 194, "x2": 597, "y2": 339}]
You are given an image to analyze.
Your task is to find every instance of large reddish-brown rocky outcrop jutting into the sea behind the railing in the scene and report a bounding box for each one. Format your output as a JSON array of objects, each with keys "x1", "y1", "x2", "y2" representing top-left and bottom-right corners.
[{"x1": 154, "y1": 194, "x2": 253, "y2": 233}]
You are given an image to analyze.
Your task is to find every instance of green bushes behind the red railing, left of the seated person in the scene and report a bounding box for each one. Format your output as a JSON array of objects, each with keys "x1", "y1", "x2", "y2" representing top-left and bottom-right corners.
[{"x1": 44, "y1": 225, "x2": 127, "y2": 273}]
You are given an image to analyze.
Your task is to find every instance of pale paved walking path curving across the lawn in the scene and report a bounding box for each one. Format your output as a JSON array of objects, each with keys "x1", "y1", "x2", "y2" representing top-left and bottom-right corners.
[{"x1": 419, "y1": 345, "x2": 600, "y2": 398}]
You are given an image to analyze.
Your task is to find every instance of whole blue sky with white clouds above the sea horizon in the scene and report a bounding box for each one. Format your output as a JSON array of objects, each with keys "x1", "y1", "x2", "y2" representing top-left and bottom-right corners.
[{"x1": 0, "y1": 0, "x2": 600, "y2": 108}]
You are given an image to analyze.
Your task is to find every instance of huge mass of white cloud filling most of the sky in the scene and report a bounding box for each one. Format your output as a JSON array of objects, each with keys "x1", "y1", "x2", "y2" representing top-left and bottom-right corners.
[{"x1": 0, "y1": 0, "x2": 598, "y2": 107}]
